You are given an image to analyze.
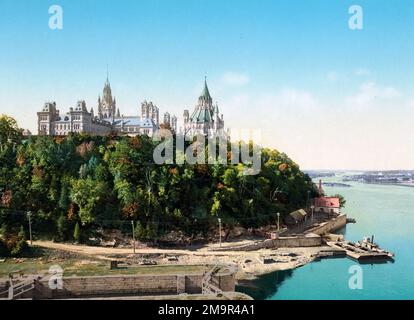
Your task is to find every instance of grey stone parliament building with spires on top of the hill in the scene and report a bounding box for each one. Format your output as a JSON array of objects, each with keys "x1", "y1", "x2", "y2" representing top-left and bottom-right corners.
[{"x1": 37, "y1": 77, "x2": 224, "y2": 137}]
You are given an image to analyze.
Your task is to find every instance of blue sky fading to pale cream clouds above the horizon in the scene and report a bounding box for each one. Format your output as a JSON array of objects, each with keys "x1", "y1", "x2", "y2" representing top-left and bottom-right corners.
[{"x1": 0, "y1": 0, "x2": 414, "y2": 170}]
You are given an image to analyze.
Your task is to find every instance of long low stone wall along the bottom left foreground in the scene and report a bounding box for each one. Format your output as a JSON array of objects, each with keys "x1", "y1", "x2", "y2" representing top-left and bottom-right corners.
[{"x1": 34, "y1": 274, "x2": 235, "y2": 299}]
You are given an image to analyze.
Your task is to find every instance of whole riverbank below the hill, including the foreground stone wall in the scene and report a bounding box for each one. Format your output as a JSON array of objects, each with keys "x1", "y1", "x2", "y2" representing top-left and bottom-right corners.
[{"x1": 0, "y1": 214, "x2": 347, "y2": 299}]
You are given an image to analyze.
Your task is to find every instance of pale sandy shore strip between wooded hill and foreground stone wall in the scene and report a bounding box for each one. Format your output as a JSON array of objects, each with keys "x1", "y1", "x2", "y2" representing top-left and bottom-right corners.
[{"x1": 0, "y1": 240, "x2": 329, "y2": 280}]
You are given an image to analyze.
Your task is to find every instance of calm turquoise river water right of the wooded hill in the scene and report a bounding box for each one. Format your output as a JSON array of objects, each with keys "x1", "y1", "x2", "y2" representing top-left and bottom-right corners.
[{"x1": 238, "y1": 177, "x2": 414, "y2": 300}]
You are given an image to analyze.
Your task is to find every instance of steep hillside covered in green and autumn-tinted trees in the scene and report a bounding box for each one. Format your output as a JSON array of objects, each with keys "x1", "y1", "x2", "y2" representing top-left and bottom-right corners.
[{"x1": 0, "y1": 116, "x2": 316, "y2": 252}]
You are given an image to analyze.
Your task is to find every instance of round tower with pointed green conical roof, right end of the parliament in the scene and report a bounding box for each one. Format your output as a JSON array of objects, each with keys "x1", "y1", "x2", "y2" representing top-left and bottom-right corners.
[{"x1": 184, "y1": 78, "x2": 224, "y2": 136}]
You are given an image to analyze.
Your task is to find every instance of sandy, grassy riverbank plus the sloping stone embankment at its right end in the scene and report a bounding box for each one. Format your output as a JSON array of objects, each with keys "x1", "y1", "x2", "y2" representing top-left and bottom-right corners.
[{"x1": 0, "y1": 215, "x2": 347, "y2": 280}]
